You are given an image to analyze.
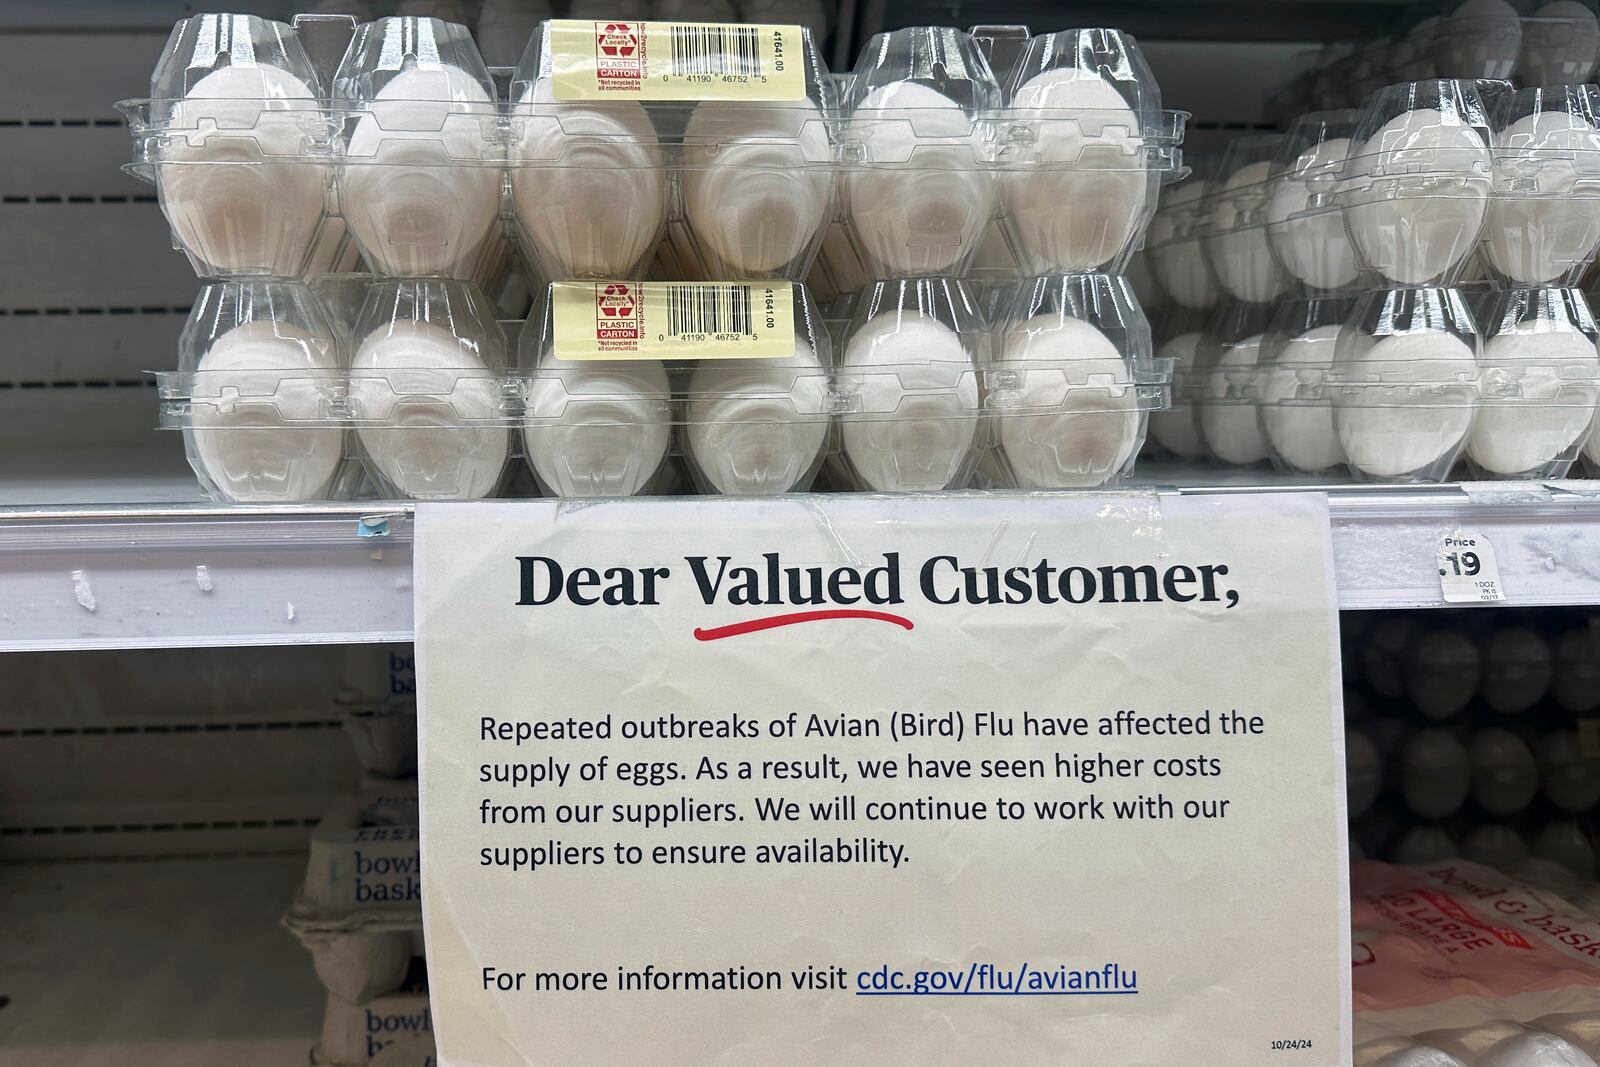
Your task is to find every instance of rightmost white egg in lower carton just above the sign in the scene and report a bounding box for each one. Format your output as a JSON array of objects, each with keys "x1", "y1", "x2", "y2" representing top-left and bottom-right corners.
[{"x1": 995, "y1": 314, "x2": 1139, "y2": 490}]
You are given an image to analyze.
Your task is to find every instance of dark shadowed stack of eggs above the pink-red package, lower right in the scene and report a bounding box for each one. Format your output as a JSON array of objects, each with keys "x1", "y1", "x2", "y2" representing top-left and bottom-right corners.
[{"x1": 1346, "y1": 614, "x2": 1600, "y2": 918}]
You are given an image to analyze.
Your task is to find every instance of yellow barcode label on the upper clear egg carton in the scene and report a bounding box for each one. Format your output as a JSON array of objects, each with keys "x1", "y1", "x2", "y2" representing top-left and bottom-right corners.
[{"x1": 550, "y1": 19, "x2": 805, "y2": 101}]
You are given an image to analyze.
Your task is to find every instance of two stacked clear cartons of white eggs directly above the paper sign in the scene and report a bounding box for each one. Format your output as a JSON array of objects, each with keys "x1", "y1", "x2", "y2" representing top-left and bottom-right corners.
[{"x1": 128, "y1": 16, "x2": 1184, "y2": 502}]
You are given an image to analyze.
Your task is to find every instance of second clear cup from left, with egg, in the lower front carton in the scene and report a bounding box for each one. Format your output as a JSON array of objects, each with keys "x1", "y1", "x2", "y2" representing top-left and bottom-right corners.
[{"x1": 349, "y1": 278, "x2": 517, "y2": 501}]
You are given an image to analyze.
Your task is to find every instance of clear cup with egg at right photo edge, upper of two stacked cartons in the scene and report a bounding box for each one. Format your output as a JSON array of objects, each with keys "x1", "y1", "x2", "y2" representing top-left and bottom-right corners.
[{"x1": 1483, "y1": 85, "x2": 1600, "y2": 286}]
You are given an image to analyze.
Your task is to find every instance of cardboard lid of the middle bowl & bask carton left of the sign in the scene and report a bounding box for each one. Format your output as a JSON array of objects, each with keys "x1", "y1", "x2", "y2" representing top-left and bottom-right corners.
[{"x1": 283, "y1": 779, "x2": 421, "y2": 936}]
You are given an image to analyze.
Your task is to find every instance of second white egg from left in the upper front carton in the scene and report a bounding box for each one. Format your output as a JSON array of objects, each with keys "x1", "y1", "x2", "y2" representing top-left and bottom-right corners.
[{"x1": 339, "y1": 66, "x2": 501, "y2": 278}]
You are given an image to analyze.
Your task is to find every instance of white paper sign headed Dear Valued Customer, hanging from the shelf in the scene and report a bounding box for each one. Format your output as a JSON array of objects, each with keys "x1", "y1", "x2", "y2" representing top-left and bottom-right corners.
[{"x1": 416, "y1": 494, "x2": 1350, "y2": 1067}]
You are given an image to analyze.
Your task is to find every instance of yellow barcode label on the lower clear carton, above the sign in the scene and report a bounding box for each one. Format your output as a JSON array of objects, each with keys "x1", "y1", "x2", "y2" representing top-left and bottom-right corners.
[{"x1": 550, "y1": 282, "x2": 795, "y2": 360}]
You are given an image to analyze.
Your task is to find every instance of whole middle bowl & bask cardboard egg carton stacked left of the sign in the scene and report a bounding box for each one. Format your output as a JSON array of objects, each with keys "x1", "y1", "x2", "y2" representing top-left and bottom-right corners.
[{"x1": 283, "y1": 781, "x2": 422, "y2": 1005}]
